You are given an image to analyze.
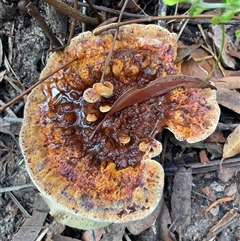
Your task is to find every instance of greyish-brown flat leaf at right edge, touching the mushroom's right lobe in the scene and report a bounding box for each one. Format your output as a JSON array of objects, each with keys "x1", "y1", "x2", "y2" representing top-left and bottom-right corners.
[{"x1": 217, "y1": 88, "x2": 240, "y2": 114}]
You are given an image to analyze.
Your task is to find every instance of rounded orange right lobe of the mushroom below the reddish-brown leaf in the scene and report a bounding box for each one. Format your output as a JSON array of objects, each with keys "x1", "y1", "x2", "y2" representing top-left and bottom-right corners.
[{"x1": 166, "y1": 88, "x2": 220, "y2": 143}]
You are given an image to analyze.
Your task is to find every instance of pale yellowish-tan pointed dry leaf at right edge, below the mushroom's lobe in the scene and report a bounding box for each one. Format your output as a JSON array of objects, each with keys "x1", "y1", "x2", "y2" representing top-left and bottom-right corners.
[{"x1": 223, "y1": 125, "x2": 240, "y2": 159}]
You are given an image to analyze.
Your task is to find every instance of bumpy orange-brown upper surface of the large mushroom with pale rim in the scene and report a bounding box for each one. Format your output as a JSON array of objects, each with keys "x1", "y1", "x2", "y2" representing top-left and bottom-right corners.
[{"x1": 20, "y1": 24, "x2": 217, "y2": 229}]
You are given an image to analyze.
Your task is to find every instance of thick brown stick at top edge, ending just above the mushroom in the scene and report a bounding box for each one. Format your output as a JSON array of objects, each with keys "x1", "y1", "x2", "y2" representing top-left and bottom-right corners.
[{"x1": 43, "y1": 0, "x2": 99, "y2": 26}]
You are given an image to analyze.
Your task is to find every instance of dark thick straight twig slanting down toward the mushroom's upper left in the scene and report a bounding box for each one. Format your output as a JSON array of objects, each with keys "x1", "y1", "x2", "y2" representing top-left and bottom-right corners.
[{"x1": 25, "y1": 0, "x2": 61, "y2": 47}]
